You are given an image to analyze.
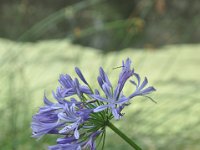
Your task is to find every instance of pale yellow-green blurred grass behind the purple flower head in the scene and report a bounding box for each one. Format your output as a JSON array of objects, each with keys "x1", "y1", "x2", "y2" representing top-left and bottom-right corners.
[{"x1": 0, "y1": 39, "x2": 200, "y2": 150}]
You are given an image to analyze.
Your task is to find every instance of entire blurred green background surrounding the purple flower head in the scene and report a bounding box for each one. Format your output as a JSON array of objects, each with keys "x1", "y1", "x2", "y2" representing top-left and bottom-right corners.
[{"x1": 0, "y1": 0, "x2": 200, "y2": 150}]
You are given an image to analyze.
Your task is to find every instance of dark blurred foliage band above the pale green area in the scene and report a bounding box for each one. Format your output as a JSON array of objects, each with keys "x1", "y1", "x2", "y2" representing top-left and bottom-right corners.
[{"x1": 0, "y1": 0, "x2": 200, "y2": 51}]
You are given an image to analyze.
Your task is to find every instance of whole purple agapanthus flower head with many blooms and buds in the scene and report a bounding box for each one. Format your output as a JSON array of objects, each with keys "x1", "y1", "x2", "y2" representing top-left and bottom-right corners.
[{"x1": 31, "y1": 58, "x2": 155, "y2": 150}]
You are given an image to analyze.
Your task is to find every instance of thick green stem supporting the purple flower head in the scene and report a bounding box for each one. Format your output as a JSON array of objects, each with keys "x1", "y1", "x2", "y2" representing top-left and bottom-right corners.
[{"x1": 107, "y1": 122, "x2": 142, "y2": 150}]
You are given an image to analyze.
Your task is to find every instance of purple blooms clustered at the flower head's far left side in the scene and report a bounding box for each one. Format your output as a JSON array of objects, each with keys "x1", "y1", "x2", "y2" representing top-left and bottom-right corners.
[{"x1": 31, "y1": 97, "x2": 92, "y2": 139}]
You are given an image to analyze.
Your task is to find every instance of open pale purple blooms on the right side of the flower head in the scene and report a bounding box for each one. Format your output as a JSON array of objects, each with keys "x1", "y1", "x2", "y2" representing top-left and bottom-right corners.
[{"x1": 91, "y1": 58, "x2": 155, "y2": 120}]
